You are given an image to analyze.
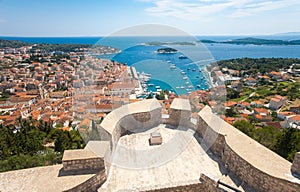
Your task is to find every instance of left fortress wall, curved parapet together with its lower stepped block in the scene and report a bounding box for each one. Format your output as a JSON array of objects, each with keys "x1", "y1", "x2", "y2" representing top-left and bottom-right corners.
[{"x1": 63, "y1": 99, "x2": 162, "y2": 192}]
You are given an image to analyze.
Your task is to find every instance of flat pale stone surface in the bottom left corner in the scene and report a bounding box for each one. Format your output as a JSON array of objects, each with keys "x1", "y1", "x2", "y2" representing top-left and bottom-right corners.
[{"x1": 0, "y1": 164, "x2": 94, "y2": 192}]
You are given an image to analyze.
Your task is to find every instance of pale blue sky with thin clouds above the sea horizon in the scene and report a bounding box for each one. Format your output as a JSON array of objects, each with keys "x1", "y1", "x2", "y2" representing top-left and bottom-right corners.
[{"x1": 0, "y1": 0, "x2": 300, "y2": 36}]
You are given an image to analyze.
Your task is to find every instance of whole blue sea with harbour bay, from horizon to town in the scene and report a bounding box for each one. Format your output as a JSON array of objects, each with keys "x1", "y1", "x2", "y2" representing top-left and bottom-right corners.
[{"x1": 0, "y1": 36, "x2": 300, "y2": 95}]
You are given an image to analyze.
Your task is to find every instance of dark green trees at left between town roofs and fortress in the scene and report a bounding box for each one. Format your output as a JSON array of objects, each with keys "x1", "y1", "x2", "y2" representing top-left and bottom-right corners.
[{"x1": 0, "y1": 119, "x2": 84, "y2": 172}]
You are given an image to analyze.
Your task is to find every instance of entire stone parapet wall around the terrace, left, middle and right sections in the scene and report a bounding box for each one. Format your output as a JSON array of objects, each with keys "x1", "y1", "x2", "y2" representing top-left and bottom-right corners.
[{"x1": 59, "y1": 99, "x2": 300, "y2": 192}]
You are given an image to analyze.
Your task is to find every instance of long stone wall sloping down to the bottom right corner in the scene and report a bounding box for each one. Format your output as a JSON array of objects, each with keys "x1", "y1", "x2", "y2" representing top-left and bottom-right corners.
[{"x1": 197, "y1": 107, "x2": 300, "y2": 192}]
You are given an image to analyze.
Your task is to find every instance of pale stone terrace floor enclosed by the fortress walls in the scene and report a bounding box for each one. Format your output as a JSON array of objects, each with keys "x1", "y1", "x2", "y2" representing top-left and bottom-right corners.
[{"x1": 98, "y1": 124, "x2": 242, "y2": 192}]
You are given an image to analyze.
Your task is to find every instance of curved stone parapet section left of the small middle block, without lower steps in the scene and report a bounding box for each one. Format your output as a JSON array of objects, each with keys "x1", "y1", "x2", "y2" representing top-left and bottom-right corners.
[{"x1": 100, "y1": 99, "x2": 162, "y2": 158}]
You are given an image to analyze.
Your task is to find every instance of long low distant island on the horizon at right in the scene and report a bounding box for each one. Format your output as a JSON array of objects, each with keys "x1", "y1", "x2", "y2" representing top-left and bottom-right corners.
[{"x1": 199, "y1": 37, "x2": 300, "y2": 45}]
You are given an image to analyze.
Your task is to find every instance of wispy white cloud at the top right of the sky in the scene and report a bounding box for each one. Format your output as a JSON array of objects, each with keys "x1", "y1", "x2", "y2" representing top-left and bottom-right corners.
[{"x1": 139, "y1": 0, "x2": 300, "y2": 20}]
